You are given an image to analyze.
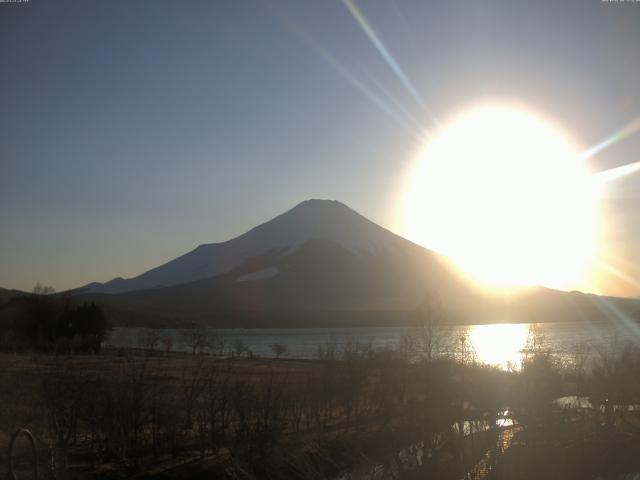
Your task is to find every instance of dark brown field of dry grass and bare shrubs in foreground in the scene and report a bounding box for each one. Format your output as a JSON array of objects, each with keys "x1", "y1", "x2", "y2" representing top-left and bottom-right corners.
[{"x1": 0, "y1": 336, "x2": 640, "y2": 480}]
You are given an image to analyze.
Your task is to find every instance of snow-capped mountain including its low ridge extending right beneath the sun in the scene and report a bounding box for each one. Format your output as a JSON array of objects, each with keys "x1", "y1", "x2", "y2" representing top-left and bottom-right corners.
[{"x1": 76, "y1": 200, "x2": 640, "y2": 327}]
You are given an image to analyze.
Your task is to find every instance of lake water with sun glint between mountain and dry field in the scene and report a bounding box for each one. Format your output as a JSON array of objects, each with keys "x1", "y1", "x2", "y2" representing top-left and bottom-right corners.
[{"x1": 106, "y1": 322, "x2": 640, "y2": 368}]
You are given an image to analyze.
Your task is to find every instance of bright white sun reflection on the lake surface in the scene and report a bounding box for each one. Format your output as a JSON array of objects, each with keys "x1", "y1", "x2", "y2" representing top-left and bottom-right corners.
[{"x1": 468, "y1": 323, "x2": 529, "y2": 368}]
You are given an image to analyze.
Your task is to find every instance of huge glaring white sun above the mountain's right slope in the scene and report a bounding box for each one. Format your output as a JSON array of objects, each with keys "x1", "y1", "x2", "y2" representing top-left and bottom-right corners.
[{"x1": 403, "y1": 105, "x2": 598, "y2": 289}]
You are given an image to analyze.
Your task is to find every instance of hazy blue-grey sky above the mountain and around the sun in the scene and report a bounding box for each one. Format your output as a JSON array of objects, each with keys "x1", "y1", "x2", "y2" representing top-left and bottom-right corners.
[{"x1": 0, "y1": 0, "x2": 640, "y2": 296}]
